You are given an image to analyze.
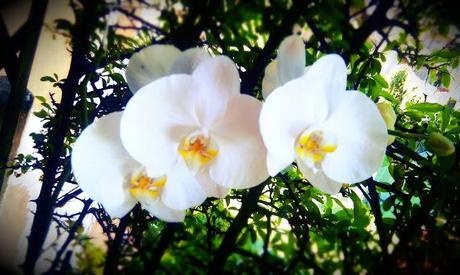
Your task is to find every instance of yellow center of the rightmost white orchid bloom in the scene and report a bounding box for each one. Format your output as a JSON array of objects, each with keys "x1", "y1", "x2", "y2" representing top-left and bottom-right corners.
[{"x1": 296, "y1": 130, "x2": 337, "y2": 168}]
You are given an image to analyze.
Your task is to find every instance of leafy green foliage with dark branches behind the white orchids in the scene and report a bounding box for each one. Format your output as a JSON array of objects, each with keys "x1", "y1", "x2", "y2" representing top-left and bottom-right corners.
[{"x1": 8, "y1": 0, "x2": 460, "y2": 274}]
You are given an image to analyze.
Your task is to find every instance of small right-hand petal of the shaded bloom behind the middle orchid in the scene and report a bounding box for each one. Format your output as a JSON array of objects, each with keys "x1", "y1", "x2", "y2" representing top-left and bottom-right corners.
[{"x1": 170, "y1": 48, "x2": 211, "y2": 74}]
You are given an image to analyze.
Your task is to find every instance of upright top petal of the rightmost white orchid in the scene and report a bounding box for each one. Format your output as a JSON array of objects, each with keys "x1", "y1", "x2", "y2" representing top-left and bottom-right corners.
[{"x1": 305, "y1": 54, "x2": 347, "y2": 108}]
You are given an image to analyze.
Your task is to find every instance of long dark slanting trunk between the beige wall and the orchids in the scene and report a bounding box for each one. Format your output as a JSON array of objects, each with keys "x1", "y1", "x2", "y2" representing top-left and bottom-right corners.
[{"x1": 23, "y1": 0, "x2": 104, "y2": 274}]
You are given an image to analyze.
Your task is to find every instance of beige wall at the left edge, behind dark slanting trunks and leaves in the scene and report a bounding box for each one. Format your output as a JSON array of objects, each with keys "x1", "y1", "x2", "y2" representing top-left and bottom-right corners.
[{"x1": 0, "y1": 0, "x2": 73, "y2": 271}]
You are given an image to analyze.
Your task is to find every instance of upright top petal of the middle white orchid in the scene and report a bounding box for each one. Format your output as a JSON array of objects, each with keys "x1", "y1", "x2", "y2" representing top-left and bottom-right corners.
[{"x1": 193, "y1": 56, "x2": 240, "y2": 127}]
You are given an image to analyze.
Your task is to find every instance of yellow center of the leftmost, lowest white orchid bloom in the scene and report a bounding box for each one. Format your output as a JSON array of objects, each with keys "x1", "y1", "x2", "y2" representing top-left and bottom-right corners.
[{"x1": 129, "y1": 172, "x2": 166, "y2": 199}]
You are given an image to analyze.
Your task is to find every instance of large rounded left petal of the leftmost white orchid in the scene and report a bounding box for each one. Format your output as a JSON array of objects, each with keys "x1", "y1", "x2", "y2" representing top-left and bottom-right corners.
[{"x1": 72, "y1": 112, "x2": 140, "y2": 217}]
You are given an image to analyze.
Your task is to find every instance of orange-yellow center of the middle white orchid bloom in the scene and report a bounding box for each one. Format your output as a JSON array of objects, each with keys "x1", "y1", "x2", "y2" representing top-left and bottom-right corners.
[{"x1": 178, "y1": 133, "x2": 219, "y2": 170}]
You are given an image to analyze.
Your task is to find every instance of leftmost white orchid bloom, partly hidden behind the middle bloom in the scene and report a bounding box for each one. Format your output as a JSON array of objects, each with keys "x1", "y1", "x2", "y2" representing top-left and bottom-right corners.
[{"x1": 72, "y1": 112, "x2": 206, "y2": 222}]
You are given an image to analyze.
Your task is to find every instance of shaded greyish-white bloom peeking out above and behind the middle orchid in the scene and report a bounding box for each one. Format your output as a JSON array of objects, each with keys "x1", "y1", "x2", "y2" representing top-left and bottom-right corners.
[{"x1": 126, "y1": 45, "x2": 211, "y2": 93}]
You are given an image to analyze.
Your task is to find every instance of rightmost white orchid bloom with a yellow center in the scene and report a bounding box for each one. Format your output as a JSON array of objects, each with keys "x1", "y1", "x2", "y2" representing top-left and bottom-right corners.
[{"x1": 260, "y1": 46, "x2": 388, "y2": 194}]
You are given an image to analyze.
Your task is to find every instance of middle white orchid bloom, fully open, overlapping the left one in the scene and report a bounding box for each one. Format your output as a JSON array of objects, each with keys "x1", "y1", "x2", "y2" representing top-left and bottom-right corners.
[{"x1": 121, "y1": 56, "x2": 268, "y2": 199}]
